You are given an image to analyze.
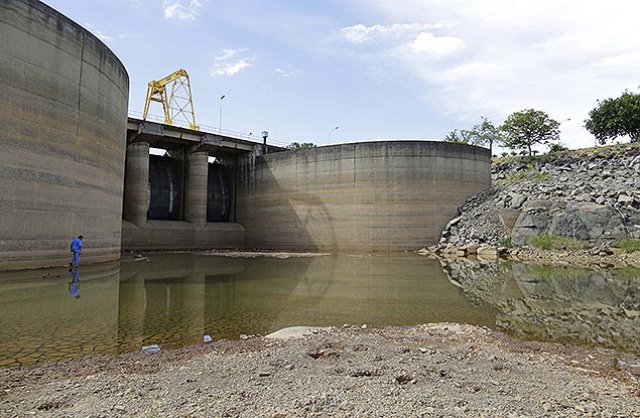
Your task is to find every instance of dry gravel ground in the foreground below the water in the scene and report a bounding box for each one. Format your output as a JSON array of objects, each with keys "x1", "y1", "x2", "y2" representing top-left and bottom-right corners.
[{"x1": 0, "y1": 324, "x2": 640, "y2": 418}]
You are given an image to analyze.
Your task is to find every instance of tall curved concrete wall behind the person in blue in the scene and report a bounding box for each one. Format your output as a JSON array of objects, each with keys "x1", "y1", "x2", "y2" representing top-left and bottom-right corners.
[{"x1": 0, "y1": 0, "x2": 129, "y2": 269}]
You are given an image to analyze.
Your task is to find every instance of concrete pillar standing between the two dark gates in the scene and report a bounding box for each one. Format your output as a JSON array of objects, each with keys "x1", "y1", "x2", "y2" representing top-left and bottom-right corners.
[{"x1": 184, "y1": 151, "x2": 209, "y2": 225}]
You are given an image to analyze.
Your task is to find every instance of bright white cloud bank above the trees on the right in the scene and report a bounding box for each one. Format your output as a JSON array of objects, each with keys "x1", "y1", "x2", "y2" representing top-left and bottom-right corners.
[{"x1": 340, "y1": 0, "x2": 640, "y2": 147}]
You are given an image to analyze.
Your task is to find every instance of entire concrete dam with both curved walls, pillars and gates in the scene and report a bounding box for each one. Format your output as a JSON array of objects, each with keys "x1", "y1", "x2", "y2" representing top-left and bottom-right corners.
[{"x1": 0, "y1": 0, "x2": 491, "y2": 270}]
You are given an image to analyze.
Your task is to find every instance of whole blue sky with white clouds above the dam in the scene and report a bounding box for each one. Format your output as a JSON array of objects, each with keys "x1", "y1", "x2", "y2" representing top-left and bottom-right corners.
[{"x1": 45, "y1": 0, "x2": 640, "y2": 148}]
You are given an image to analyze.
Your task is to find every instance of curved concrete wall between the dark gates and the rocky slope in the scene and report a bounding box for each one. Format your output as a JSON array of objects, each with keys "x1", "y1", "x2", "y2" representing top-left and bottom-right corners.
[{"x1": 236, "y1": 141, "x2": 491, "y2": 252}]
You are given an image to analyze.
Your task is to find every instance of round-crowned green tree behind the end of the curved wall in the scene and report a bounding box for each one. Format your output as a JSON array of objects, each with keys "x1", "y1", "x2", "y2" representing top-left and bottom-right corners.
[{"x1": 500, "y1": 109, "x2": 560, "y2": 156}]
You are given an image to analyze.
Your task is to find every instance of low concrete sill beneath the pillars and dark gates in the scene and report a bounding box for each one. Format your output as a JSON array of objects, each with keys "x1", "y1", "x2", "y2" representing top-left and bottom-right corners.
[{"x1": 122, "y1": 221, "x2": 245, "y2": 251}]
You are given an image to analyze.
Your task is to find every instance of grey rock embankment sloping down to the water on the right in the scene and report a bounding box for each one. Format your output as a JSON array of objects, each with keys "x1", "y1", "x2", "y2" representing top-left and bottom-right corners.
[{"x1": 432, "y1": 144, "x2": 640, "y2": 262}]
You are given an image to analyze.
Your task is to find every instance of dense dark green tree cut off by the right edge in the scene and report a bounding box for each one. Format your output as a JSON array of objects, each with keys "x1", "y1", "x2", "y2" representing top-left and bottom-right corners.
[{"x1": 584, "y1": 90, "x2": 640, "y2": 145}]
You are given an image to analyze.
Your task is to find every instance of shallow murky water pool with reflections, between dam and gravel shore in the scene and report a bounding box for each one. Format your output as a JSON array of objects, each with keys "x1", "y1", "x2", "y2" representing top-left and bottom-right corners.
[{"x1": 0, "y1": 253, "x2": 640, "y2": 367}]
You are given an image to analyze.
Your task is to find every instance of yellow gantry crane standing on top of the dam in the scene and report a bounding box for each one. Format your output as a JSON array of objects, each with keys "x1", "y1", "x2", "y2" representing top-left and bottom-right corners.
[{"x1": 143, "y1": 69, "x2": 198, "y2": 130}]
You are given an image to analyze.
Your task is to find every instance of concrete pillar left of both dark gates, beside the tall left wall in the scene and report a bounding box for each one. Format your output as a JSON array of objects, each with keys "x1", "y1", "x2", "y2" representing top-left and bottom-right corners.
[{"x1": 122, "y1": 142, "x2": 149, "y2": 226}]
